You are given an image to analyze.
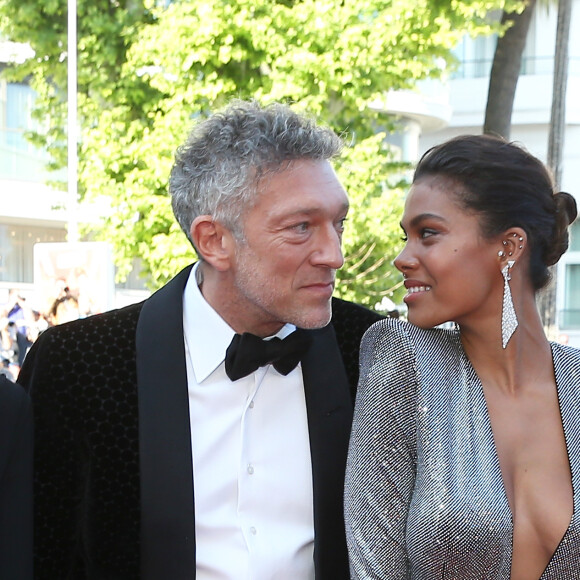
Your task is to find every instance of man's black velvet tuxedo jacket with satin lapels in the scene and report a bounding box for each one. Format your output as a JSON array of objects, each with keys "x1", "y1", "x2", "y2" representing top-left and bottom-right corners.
[{"x1": 19, "y1": 268, "x2": 380, "y2": 580}]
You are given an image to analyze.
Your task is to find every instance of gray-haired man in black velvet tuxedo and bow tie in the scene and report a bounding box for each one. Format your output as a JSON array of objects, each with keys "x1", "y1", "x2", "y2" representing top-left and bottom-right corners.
[{"x1": 19, "y1": 101, "x2": 380, "y2": 580}]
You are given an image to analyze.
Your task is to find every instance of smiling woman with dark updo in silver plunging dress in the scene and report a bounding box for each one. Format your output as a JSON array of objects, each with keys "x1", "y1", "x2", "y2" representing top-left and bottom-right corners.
[{"x1": 345, "y1": 135, "x2": 580, "y2": 580}]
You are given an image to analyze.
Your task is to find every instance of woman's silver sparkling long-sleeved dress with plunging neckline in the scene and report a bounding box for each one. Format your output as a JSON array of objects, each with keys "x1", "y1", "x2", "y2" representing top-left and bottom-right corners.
[{"x1": 345, "y1": 319, "x2": 580, "y2": 580}]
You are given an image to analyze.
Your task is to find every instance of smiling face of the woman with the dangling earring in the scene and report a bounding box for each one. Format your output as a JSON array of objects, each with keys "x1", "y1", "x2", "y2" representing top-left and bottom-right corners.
[{"x1": 394, "y1": 176, "x2": 503, "y2": 328}]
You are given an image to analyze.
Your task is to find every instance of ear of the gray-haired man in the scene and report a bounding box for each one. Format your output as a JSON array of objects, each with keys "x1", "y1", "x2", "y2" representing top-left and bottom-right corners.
[{"x1": 190, "y1": 215, "x2": 235, "y2": 272}]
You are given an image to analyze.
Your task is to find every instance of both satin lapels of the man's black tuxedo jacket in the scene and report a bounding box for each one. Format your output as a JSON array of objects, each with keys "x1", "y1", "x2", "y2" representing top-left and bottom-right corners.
[{"x1": 136, "y1": 267, "x2": 352, "y2": 580}]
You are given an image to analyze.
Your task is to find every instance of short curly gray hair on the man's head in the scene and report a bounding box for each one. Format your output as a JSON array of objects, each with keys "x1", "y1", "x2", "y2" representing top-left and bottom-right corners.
[{"x1": 169, "y1": 100, "x2": 343, "y2": 241}]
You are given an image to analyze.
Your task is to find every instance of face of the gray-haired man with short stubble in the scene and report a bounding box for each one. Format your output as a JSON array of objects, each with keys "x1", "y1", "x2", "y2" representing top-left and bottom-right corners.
[{"x1": 223, "y1": 160, "x2": 348, "y2": 336}]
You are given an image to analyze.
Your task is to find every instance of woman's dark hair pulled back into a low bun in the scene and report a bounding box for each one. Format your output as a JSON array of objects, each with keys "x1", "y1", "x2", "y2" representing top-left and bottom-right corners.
[{"x1": 413, "y1": 135, "x2": 577, "y2": 290}]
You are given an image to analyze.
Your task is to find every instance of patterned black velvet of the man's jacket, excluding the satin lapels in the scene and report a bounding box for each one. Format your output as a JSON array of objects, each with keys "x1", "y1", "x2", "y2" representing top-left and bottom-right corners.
[{"x1": 19, "y1": 300, "x2": 380, "y2": 580}]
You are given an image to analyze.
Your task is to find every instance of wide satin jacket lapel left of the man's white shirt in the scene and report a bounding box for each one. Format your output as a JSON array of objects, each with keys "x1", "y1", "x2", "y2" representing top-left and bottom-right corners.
[{"x1": 136, "y1": 267, "x2": 195, "y2": 580}]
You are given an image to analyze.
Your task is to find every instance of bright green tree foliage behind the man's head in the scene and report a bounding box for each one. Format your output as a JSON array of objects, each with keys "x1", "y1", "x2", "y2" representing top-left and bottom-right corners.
[{"x1": 0, "y1": 0, "x2": 517, "y2": 305}]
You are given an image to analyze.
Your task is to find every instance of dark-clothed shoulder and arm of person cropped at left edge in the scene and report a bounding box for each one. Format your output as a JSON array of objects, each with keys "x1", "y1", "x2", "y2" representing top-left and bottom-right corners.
[{"x1": 0, "y1": 375, "x2": 32, "y2": 580}]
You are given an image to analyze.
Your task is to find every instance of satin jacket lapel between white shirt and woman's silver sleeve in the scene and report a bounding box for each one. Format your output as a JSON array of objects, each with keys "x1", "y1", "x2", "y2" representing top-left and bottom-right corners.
[{"x1": 302, "y1": 325, "x2": 352, "y2": 580}]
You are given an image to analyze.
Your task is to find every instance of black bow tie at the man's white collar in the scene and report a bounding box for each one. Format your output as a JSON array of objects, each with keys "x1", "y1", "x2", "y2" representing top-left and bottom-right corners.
[{"x1": 226, "y1": 330, "x2": 311, "y2": 381}]
